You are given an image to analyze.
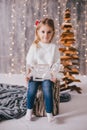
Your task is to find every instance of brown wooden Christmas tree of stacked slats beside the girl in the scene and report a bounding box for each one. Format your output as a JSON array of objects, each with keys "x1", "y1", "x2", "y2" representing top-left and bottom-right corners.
[{"x1": 59, "y1": 9, "x2": 81, "y2": 93}]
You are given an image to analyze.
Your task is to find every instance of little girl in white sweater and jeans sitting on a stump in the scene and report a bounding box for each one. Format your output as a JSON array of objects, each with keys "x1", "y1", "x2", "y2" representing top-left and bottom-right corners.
[{"x1": 26, "y1": 18, "x2": 60, "y2": 122}]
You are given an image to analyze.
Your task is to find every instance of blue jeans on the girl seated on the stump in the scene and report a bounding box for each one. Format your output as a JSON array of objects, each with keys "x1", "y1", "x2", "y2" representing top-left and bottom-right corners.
[{"x1": 27, "y1": 79, "x2": 53, "y2": 113}]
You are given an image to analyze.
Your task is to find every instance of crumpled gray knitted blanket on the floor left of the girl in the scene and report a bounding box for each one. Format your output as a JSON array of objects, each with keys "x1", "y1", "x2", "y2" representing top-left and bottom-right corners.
[{"x1": 0, "y1": 84, "x2": 27, "y2": 121}]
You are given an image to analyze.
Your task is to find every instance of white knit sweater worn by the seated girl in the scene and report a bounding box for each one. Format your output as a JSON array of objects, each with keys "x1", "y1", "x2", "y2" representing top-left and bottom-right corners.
[{"x1": 26, "y1": 42, "x2": 60, "y2": 78}]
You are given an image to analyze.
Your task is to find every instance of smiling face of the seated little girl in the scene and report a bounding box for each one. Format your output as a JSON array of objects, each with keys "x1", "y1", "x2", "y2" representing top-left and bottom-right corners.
[{"x1": 38, "y1": 25, "x2": 54, "y2": 43}]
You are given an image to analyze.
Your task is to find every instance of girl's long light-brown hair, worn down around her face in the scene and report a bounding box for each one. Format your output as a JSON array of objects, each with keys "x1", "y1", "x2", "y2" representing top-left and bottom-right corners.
[{"x1": 33, "y1": 18, "x2": 55, "y2": 46}]
